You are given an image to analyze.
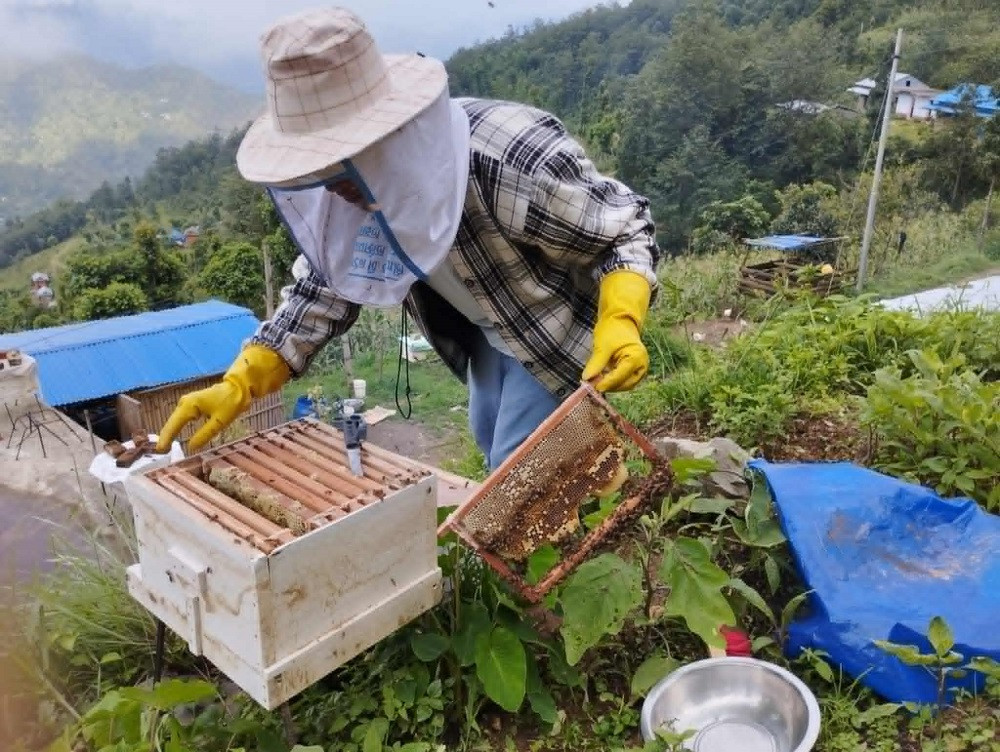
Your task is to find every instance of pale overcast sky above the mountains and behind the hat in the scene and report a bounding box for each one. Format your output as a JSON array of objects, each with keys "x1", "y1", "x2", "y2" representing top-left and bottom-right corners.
[{"x1": 0, "y1": 0, "x2": 627, "y2": 89}]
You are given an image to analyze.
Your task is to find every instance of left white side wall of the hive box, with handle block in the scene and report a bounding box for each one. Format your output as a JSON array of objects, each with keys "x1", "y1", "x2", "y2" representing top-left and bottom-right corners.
[{"x1": 126, "y1": 475, "x2": 267, "y2": 668}]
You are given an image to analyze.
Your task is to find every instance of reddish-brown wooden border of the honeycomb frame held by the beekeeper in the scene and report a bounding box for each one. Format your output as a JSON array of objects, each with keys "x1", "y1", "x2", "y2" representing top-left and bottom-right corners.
[{"x1": 438, "y1": 383, "x2": 660, "y2": 603}]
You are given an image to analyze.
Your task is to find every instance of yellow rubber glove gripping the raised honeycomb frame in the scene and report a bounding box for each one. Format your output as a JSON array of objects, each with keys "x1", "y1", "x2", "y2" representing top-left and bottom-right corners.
[{"x1": 583, "y1": 270, "x2": 652, "y2": 392}]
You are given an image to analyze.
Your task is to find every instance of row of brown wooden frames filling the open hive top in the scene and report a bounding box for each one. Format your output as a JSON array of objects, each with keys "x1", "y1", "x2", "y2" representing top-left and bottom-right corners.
[{"x1": 147, "y1": 419, "x2": 428, "y2": 553}]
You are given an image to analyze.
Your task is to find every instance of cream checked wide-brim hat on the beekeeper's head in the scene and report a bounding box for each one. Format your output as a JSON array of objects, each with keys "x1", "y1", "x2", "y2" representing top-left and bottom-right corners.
[{"x1": 236, "y1": 8, "x2": 448, "y2": 186}]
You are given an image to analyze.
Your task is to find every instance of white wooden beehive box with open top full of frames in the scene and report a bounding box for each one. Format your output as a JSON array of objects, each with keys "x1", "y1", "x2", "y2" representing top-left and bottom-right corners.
[{"x1": 125, "y1": 419, "x2": 441, "y2": 709}]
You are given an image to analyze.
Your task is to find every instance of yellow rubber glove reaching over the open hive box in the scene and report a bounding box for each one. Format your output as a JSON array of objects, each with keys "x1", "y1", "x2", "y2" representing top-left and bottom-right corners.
[{"x1": 156, "y1": 345, "x2": 291, "y2": 454}]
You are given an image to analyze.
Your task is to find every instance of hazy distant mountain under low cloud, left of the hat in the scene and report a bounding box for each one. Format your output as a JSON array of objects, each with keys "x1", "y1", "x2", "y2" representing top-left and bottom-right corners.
[{"x1": 0, "y1": 51, "x2": 259, "y2": 221}]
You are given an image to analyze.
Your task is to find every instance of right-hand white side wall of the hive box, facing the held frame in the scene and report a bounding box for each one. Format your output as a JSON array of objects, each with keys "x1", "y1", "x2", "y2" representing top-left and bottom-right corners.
[{"x1": 261, "y1": 477, "x2": 437, "y2": 663}]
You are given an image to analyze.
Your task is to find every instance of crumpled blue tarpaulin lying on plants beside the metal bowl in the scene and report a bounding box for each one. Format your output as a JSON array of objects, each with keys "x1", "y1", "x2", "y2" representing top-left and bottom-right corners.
[{"x1": 749, "y1": 460, "x2": 1000, "y2": 703}]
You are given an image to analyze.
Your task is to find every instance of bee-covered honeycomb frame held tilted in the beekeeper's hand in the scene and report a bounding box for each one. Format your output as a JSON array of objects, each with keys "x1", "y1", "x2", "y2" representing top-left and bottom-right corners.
[{"x1": 438, "y1": 385, "x2": 670, "y2": 602}]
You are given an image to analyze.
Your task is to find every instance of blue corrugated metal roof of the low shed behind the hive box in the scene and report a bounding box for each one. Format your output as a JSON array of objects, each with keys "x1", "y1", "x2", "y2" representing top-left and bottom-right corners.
[{"x1": 0, "y1": 300, "x2": 258, "y2": 405}]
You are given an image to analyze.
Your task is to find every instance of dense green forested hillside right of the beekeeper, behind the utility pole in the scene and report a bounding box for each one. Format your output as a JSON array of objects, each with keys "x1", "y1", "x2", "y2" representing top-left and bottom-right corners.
[{"x1": 449, "y1": 0, "x2": 1000, "y2": 244}]
